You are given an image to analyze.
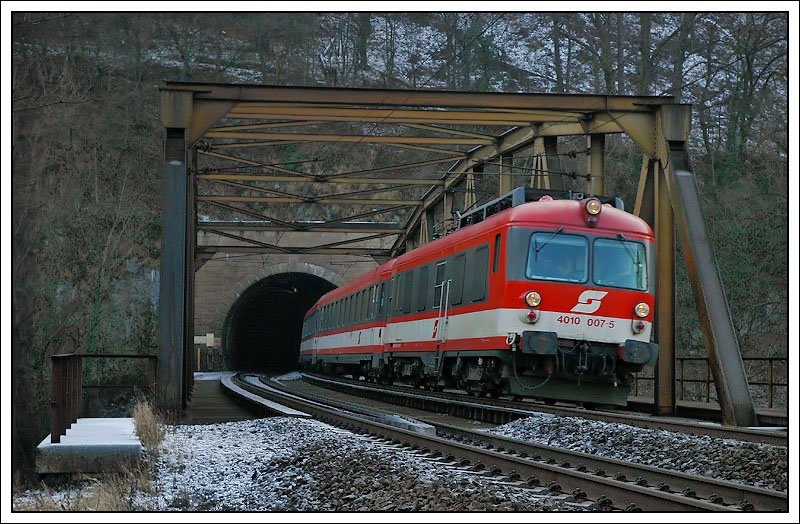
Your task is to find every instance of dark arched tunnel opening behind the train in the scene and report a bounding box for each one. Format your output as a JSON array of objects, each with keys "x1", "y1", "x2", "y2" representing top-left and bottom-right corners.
[{"x1": 223, "y1": 273, "x2": 336, "y2": 373}]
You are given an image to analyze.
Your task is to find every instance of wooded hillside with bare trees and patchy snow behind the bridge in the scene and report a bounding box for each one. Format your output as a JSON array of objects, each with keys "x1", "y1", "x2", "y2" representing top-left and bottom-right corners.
[{"x1": 11, "y1": 14, "x2": 788, "y2": 476}]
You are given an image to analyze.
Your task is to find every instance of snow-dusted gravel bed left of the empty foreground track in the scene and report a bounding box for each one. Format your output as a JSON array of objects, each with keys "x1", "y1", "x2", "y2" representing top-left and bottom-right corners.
[{"x1": 147, "y1": 418, "x2": 574, "y2": 511}]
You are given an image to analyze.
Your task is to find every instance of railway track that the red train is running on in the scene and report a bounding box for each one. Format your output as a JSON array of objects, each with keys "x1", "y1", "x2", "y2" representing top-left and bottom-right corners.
[{"x1": 303, "y1": 373, "x2": 788, "y2": 447}]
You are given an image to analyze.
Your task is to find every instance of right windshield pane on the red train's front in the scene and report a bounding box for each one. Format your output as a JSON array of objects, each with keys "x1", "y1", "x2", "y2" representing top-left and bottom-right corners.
[{"x1": 592, "y1": 238, "x2": 647, "y2": 291}]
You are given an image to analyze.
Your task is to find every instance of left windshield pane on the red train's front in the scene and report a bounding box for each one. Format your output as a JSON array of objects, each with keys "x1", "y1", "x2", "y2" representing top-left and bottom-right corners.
[{"x1": 526, "y1": 229, "x2": 589, "y2": 282}]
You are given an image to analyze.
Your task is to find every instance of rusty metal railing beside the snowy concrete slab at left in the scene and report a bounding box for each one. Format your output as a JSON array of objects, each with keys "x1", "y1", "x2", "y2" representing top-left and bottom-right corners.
[{"x1": 50, "y1": 353, "x2": 158, "y2": 444}]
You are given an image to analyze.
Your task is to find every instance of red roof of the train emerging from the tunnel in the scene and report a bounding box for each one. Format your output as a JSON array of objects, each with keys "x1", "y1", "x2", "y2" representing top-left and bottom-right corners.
[{"x1": 309, "y1": 196, "x2": 653, "y2": 313}]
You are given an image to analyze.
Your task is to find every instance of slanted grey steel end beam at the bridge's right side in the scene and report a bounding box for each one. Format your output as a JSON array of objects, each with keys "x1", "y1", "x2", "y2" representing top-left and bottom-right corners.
[{"x1": 667, "y1": 143, "x2": 758, "y2": 426}]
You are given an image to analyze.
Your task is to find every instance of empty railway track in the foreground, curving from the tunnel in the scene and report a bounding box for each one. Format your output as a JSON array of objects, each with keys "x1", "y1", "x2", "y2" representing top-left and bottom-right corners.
[{"x1": 225, "y1": 377, "x2": 788, "y2": 511}]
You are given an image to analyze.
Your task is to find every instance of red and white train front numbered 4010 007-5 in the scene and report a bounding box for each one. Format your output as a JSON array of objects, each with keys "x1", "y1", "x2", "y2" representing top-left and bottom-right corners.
[{"x1": 499, "y1": 198, "x2": 658, "y2": 405}]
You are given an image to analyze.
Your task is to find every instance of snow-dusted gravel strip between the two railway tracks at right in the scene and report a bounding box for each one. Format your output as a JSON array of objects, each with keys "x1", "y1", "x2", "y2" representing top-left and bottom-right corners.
[{"x1": 492, "y1": 414, "x2": 788, "y2": 491}]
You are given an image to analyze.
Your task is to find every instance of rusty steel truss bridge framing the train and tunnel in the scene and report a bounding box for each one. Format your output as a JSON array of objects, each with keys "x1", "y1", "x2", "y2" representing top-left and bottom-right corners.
[{"x1": 159, "y1": 82, "x2": 756, "y2": 426}]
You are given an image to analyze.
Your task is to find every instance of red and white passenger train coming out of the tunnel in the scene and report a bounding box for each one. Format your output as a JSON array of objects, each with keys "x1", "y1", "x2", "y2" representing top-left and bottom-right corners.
[{"x1": 299, "y1": 187, "x2": 658, "y2": 406}]
